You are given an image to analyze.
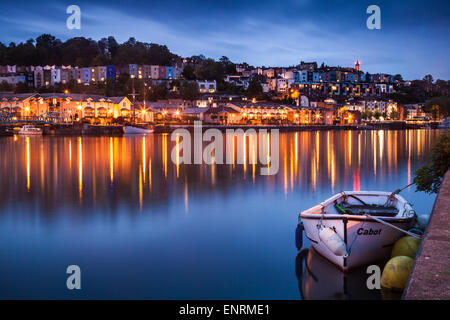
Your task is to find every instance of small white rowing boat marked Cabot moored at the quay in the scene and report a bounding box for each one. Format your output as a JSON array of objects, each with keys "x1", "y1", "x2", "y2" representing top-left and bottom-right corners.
[{"x1": 296, "y1": 191, "x2": 416, "y2": 270}]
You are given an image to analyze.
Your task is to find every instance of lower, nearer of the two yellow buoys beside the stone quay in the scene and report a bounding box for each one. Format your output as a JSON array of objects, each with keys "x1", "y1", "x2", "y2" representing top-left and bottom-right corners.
[{"x1": 381, "y1": 256, "x2": 414, "y2": 290}]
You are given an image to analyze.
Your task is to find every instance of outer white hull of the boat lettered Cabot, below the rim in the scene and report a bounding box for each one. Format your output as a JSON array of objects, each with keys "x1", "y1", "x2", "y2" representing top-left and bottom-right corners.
[{"x1": 300, "y1": 214, "x2": 414, "y2": 271}]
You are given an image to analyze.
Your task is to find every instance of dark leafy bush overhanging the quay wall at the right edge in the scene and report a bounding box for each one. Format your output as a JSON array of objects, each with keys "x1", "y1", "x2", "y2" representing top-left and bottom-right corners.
[{"x1": 414, "y1": 130, "x2": 450, "y2": 193}]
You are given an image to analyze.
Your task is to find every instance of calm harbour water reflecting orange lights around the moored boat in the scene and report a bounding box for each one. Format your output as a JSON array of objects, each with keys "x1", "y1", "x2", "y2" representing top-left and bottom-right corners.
[{"x1": 0, "y1": 130, "x2": 439, "y2": 299}]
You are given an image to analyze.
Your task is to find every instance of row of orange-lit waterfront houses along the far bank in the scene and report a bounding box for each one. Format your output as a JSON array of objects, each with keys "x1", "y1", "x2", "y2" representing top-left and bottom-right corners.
[{"x1": 0, "y1": 93, "x2": 420, "y2": 125}]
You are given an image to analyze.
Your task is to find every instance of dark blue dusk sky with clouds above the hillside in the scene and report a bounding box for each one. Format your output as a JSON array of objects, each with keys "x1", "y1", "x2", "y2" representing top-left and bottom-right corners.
[{"x1": 0, "y1": 0, "x2": 450, "y2": 80}]
